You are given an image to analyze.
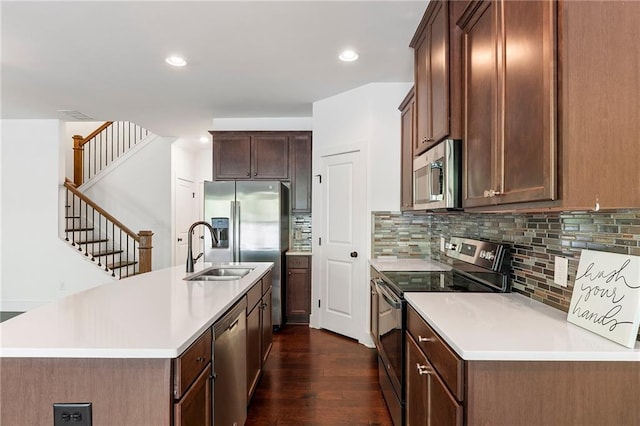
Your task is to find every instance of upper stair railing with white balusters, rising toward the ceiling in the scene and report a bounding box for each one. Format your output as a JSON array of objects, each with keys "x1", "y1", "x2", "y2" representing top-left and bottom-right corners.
[{"x1": 73, "y1": 121, "x2": 150, "y2": 187}]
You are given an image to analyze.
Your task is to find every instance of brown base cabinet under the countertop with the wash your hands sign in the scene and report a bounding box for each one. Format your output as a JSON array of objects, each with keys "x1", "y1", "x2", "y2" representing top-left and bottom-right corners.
[{"x1": 405, "y1": 306, "x2": 640, "y2": 426}]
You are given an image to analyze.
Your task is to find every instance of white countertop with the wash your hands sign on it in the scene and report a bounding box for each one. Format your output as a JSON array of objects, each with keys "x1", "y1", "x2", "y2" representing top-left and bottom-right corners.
[{"x1": 405, "y1": 293, "x2": 640, "y2": 361}]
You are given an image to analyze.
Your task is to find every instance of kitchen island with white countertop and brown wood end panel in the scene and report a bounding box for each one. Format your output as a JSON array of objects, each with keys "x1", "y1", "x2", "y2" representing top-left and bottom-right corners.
[{"x1": 0, "y1": 263, "x2": 273, "y2": 426}]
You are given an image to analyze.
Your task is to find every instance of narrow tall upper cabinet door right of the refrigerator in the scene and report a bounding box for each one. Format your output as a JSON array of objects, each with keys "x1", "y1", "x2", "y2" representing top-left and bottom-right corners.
[{"x1": 289, "y1": 133, "x2": 311, "y2": 213}]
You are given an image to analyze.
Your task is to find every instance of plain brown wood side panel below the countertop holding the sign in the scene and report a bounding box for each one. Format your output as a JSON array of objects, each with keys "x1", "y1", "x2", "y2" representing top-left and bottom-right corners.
[{"x1": 465, "y1": 361, "x2": 640, "y2": 426}]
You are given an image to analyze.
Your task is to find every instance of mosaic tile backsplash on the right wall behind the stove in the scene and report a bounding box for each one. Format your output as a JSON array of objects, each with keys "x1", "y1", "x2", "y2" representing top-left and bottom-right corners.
[{"x1": 371, "y1": 210, "x2": 640, "y2": 340}]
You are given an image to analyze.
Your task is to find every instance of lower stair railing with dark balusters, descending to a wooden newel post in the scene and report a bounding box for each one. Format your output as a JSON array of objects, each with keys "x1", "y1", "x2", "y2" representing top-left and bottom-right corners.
[{"x1": 64, "y1": 180, "x2": 153, "y2": 278}]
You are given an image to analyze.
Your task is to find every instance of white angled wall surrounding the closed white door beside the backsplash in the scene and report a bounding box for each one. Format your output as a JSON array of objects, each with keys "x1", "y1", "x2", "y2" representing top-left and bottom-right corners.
[{"x1": 311, "y1": 83, "x2": 412, "y2": 345}]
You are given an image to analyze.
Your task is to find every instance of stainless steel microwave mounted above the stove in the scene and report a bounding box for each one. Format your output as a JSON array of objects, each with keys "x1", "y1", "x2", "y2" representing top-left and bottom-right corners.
[{"x1": 413, "y1": 139, "x2": 462, "y2": 210}]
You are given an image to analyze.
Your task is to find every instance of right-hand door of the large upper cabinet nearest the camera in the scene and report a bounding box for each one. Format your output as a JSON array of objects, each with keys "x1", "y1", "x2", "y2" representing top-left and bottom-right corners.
[{"x1": 499, "y1": 0, "x2": 556, "y2": 204}]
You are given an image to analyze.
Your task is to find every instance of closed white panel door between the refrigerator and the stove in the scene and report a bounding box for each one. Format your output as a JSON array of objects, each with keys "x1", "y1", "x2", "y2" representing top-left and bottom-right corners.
[{"x1": 319, "y1": 151, "x2": 368, "y2": 339}]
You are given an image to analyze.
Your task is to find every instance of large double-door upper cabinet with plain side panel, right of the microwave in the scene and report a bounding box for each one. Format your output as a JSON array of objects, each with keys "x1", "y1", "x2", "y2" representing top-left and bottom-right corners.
[{"x1": 454, "y1": 0, "x2": 640, "y2": 210}]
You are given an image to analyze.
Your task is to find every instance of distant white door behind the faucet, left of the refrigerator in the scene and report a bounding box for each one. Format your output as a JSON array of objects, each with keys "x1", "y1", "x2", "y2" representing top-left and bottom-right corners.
[{"x1": 173, "y1": 178, "x2": 200, "y2": 265}]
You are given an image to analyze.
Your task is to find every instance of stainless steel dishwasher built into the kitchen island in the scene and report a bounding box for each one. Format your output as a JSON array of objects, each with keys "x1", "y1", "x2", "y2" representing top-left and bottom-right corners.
[{"x1": 213, "y1": 298, "x2": 247, "y2": 426}]
